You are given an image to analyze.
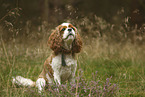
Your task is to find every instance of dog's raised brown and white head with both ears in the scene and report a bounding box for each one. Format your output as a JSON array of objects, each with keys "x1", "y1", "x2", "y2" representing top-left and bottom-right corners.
[{"x1": 48, "y1": 23, "x2": 82, "y2": 54}]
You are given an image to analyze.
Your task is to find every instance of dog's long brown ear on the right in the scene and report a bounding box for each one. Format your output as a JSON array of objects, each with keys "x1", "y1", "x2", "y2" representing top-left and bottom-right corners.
[{"x1": 72, "y1": 33, "x2": 82, "y2": 53}]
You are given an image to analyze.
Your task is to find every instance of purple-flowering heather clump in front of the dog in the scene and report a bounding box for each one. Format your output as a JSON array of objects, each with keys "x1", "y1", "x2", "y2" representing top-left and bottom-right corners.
[{"x1": 41, "y1": 70, "x2": 118, "y2": 97}]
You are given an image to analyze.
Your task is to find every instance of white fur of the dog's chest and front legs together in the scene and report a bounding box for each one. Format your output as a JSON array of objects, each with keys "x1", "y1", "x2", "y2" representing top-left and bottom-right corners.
[{"x1": 48, "y1": 54, "x2": 77, "y2": 85}]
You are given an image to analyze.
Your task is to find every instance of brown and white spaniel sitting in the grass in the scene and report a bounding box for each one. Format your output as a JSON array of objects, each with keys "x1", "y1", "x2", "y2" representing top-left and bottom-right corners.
[{"x1": 13, "y1": 23, "x2": 82, "y2": 93}]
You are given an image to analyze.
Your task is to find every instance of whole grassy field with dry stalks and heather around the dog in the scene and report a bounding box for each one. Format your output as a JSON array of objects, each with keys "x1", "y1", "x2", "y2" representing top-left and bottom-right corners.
[{"x1": 0, "y1": 17, "x2": 145, "y2": 97}]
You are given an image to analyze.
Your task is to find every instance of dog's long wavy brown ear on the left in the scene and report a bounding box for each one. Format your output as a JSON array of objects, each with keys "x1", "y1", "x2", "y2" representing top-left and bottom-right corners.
[{"x1": 48, "y1": 25, "x2": 62, "y2": 54}]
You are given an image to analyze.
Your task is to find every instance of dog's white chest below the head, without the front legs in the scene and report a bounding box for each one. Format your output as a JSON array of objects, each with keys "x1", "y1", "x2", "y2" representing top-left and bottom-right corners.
[{"x1": 51, "y1": 54, "x2": 77, "y2": 80}]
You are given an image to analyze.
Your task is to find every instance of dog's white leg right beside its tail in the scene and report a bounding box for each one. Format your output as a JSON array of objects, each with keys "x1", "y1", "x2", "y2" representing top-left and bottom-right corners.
[{"x1": 36, "y1": 78, "x2": 46, "y2": 93}]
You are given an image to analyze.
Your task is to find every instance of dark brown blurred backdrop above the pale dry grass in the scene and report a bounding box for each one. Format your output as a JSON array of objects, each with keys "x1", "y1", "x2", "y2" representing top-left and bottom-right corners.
[{"x1": 0, "y1": 0, "x2": 145, "y2": 42}]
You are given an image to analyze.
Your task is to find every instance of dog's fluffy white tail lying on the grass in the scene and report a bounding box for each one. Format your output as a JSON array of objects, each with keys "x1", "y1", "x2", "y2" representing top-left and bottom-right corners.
[{"x1": 12, "y1": 76, "x2": 36, "y2": 87}]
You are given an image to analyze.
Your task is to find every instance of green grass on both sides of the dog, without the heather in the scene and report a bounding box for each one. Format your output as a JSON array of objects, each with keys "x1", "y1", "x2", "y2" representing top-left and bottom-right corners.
[{"x1": 0, "y1": 41, "x2": 145, "y2": 97}]
